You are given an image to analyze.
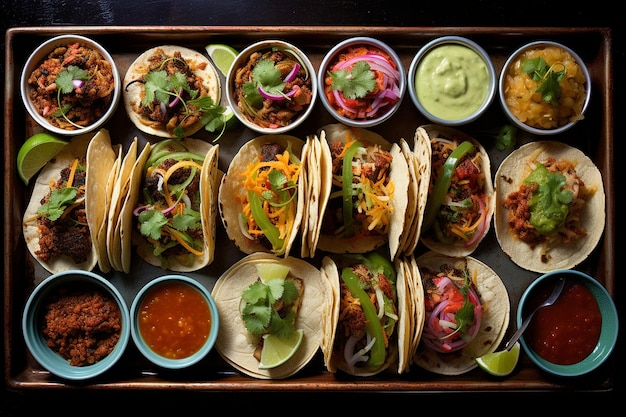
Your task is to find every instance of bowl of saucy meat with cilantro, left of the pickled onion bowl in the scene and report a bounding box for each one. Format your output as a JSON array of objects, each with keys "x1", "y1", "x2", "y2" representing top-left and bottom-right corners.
[{"x1": 226, "y1": 40, "x2": 317, "y2": 134}]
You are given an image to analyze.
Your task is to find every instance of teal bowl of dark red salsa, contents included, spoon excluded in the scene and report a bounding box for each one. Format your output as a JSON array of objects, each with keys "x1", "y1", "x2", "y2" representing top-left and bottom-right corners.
[{"x1": 517, "y1": 270, "x2": 619, "y2": 377}]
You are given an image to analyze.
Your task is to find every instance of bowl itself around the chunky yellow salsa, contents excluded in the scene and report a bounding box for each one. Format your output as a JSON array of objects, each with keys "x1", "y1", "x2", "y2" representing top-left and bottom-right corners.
[{"x1": 498, "y1": 41, "x2": 591, "y2": 135}]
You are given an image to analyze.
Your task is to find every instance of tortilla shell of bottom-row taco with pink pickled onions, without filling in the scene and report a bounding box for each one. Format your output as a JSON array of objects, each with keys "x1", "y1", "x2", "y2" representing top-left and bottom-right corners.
[{"x1": 413, "y1": 251, "x2": 511, "y2": 375}]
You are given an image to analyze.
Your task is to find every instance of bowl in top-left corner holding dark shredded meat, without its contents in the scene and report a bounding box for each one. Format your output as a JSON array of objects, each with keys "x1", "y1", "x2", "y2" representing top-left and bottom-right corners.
[{"x1": 20, "y1": 35, "x2": 122, "y2": 136}]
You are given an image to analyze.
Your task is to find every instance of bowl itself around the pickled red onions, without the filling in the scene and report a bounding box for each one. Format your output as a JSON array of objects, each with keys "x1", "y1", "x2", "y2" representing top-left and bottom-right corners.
[{"x1": 317, "y1": 36, "x2": 406, "y2": 128}]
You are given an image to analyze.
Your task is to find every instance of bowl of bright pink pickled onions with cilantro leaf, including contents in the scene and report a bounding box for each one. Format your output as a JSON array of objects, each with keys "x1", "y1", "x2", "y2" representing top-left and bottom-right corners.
[{"x1": 317, "y1": 36, "x2": 406, "y2": 128}]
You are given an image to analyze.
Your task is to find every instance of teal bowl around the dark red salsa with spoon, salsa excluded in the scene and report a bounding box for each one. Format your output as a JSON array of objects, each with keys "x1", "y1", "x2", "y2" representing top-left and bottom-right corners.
[{"x1": 517, "y1": 269, "x2": 619, "y2": 377}]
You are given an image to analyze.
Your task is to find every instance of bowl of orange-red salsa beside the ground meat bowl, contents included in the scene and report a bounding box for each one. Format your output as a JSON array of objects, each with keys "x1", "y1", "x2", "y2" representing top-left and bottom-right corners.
[{"x1": 130, "y1": 275, "x2": 219, "y2": 369}]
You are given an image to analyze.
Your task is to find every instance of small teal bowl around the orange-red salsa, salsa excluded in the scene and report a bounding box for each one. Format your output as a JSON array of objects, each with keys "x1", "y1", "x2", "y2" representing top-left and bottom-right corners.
[{"x1": 130, "y1": 275, "x2": 219, "y2": 369}]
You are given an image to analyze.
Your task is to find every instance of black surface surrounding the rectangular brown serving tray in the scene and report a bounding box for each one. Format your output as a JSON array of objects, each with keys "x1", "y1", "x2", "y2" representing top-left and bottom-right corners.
[{"x1": 0, "y1": 0, "x2": 625, "y2": 416}]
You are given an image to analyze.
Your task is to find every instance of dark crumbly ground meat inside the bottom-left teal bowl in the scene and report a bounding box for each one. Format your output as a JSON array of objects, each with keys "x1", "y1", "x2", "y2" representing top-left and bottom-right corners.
[{"x1": 42, "y1": 287, "x2": 122, "y2": 366}]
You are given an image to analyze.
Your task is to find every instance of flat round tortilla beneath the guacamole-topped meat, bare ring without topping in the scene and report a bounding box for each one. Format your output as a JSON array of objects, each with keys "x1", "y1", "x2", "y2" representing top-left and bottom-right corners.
[{"x1": 494, "y1": 141, "x2": 606, "y2": 273}]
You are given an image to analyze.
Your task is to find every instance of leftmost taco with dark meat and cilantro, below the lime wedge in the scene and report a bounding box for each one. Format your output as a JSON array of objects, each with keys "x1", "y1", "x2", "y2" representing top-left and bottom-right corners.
[{"x1": 22, "y1": 134, "x2": 96, "y2": 274}]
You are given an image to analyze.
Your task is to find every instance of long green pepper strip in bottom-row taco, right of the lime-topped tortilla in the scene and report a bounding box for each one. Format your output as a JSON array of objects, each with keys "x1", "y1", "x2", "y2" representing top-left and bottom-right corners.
[{"x1": 341, "y1": 268, "x2": 386, "y2": 367}]
